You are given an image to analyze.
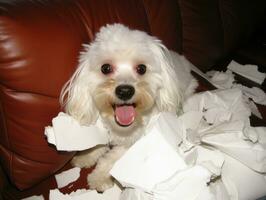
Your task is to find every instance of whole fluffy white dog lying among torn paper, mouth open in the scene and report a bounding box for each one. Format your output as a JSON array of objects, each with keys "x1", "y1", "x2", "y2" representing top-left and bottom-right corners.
[{"x1": 61, "y1": 24, "x2": 197, "y2": 191}]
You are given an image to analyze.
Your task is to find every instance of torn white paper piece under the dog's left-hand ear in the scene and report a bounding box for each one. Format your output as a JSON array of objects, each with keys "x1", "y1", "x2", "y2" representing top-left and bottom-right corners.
[{"x1": 45, "y1": 112, "x2": 109, "y2": 151}]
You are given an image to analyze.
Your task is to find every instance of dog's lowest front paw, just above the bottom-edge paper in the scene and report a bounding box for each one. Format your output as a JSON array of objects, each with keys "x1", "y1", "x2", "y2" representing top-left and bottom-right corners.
[{"x1": 87, "y1": 172, "x2": 114, "y2": 192}]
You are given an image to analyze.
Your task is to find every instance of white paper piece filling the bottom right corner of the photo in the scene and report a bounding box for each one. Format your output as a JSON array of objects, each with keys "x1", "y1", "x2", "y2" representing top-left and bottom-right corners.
[{"x1": 222, "y1": 154, "x2": 266, "y2": 200}]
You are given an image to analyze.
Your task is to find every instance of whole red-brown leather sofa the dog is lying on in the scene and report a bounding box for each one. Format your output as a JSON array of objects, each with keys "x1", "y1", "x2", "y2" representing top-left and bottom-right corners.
[{"x1": 0, "y1": 0, "x2": 266, "y2": 199}]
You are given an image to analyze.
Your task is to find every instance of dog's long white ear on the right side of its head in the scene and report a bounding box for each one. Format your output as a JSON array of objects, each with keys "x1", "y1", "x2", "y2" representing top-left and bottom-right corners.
[{"x1": 152, "y1": 39, "x2": 183, "y2": 112}]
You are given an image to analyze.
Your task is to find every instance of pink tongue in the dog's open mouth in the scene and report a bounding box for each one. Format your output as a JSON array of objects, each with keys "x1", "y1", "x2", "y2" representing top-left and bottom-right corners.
[{"x1": 115, "y1": 106, "x2": 136, "y2": 126}]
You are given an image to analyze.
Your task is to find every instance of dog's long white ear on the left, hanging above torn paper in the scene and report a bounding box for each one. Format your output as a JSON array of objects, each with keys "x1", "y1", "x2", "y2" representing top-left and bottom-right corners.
[{"x1": 60, "y1": 47, "x2": 99, "y2": 125}]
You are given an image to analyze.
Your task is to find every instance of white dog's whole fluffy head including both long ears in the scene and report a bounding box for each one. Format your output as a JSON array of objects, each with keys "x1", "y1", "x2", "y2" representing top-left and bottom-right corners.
[{"x1": 60, "y1": 24, "x2": 181, "y2": 134}]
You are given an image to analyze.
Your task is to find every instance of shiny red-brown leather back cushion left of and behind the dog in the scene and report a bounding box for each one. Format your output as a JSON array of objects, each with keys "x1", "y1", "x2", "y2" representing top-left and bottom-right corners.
[{"x1": 0, "y1": 0, "x2": 181, "y2": 189}]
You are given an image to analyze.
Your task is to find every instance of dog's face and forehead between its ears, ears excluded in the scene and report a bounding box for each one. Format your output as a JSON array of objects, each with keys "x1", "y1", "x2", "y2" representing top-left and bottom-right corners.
[{"x1": 89, "y1": 26, "x2": 162, "y2": 133}]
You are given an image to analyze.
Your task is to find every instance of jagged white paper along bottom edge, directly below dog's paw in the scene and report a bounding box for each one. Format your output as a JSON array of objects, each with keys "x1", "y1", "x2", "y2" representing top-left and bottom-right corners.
[{"x1": 49, "y1": 185, "x2": 121, "y2": 200}]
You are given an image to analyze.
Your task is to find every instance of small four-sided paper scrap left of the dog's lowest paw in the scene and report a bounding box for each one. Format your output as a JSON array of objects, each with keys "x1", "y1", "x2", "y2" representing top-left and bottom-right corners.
[{"x1": 55, "y1": 167, "x2": 80, "y2": 188}]
